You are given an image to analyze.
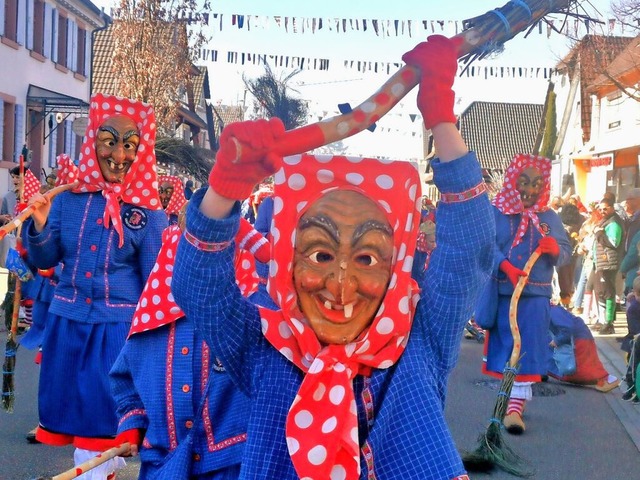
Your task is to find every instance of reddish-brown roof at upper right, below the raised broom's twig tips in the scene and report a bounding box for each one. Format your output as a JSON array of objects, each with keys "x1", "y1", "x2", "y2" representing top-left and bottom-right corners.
[{"x1": 557, "y1": 35, "x2": 633, "y2": 143}]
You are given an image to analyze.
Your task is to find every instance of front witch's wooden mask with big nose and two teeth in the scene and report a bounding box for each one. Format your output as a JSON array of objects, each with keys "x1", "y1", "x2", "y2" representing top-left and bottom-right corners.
[{"x1": 293, "y1": 191, "x2": 393, "y2": 345}]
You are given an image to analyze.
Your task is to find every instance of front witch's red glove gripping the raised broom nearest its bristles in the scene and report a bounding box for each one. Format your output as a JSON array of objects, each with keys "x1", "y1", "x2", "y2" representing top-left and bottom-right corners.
[{"x1": 402, "y1": 35, "x2": 463, "y2": 129}]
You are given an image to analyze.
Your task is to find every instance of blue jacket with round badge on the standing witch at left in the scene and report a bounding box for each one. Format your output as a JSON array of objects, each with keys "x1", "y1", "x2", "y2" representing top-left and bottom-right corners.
[{"x1": 25, "y1": 192, "x2": 167, "y2": 323}]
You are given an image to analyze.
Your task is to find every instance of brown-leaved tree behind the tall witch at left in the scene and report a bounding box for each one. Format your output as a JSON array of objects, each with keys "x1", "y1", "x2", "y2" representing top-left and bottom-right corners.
[{"x1": 112, "y1": 0, "x2": 210, "y2": 134}]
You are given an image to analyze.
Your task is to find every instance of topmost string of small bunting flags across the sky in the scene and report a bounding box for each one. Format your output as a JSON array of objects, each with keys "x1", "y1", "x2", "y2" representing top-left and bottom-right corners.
[{"x1": 181, "y1": 13, "x2": 635, "y2": 38}]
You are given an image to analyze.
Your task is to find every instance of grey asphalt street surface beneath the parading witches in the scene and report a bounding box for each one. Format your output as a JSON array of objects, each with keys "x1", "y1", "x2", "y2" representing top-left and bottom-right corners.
[{"x1": 0, "y1": 316, "x2": 640, "y2": 480}]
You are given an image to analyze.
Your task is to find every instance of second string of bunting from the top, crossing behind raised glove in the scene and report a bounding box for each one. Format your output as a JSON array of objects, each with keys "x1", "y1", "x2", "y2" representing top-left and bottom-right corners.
[{"x1": 198, "y1": 48, "x2": 556, "y2": 79}]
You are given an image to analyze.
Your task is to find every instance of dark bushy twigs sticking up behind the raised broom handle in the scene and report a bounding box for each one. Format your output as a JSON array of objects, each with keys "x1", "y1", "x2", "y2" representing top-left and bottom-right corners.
[{"x1": 242, "y1": 64, "x2": 309, "y2": 130}]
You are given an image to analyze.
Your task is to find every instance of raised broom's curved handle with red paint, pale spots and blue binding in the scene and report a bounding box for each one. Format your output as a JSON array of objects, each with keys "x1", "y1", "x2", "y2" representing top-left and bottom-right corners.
[{"x1": 231, "y1": 0, "x2": 571, "y2": 160}]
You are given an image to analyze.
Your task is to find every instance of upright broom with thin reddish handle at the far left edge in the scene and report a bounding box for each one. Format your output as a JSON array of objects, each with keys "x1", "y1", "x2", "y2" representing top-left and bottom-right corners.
[{"x1": 2, "y1": 155, "x2": 24, "y2": 413}]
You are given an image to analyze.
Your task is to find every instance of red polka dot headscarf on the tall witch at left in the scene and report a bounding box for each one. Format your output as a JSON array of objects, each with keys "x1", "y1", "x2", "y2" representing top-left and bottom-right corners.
[{"x1": 73, "y1": 93, "x2": 162, "y2": 246}]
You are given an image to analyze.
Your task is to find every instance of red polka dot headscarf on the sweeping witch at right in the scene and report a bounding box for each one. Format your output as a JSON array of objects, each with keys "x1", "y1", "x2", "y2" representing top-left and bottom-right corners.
[{"x1": 493, "y1": 153, "x2": 551, "y2": 248}]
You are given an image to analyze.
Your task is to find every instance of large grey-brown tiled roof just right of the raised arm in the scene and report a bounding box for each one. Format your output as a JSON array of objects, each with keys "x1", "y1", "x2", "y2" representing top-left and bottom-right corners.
[{"x1": 460, "y1": 102, "x2": 544, "y2": 170}]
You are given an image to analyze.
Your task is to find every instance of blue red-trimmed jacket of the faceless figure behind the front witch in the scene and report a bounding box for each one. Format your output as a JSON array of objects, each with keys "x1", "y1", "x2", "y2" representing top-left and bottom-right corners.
[{"x1": 109, "y1": 317, "x2": 249, "y2": 479}]
